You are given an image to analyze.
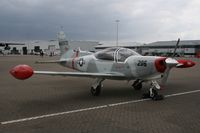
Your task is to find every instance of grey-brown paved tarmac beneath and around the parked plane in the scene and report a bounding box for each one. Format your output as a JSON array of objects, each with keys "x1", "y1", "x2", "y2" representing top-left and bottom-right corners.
[{"x1": 0, "y1": 56, "x2": 200, "y2": 133}]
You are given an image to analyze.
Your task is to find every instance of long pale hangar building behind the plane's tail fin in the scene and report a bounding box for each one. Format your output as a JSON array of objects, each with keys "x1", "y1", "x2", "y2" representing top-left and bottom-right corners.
[{"x1": 0, "y1": 40, "x2": 99, "y2": 55}]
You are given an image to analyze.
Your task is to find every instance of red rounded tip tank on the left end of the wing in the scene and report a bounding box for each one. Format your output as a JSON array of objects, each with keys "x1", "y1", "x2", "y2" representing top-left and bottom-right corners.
[{"x1": 10, "y1": 65, "x2": 33, "y2": 80}]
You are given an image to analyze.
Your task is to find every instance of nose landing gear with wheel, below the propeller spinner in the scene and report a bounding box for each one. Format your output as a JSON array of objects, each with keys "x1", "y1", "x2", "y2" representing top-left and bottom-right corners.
[{"x1": 143, "y1": 81, "x2": 164, "y2": 101}]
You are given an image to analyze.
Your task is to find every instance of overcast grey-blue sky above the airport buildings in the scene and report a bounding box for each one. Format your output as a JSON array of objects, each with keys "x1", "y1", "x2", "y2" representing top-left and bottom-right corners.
[{"x1": 0, "y1": 0, "x2": 200, "y2": 42}]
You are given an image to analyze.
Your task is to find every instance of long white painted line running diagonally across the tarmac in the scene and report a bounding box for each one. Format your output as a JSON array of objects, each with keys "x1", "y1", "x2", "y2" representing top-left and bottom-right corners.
[{"x1": 1, "y1": 90, "x2": 200, "y2": 125}]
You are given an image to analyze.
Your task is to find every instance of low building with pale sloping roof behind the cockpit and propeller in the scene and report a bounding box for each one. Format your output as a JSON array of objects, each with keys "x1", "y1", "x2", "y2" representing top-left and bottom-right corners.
[{"x1": 95, "y1": 40, "x2": 200, "y2": 57}]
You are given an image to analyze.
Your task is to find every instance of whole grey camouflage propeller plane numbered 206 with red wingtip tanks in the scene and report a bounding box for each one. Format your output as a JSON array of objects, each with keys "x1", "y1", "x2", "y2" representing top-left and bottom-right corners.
[{"x1": 10, "y1": 32, "x2": 195, "y2": 100}]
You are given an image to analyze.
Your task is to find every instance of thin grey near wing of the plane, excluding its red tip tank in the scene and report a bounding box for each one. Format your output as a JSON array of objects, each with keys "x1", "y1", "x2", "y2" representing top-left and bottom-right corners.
[{"x1": 34, "y1": 71, "x2": 125, "y2": 79}]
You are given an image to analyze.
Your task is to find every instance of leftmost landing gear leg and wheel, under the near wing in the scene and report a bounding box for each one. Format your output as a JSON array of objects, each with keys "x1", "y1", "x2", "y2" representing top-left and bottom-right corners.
[{"x1": 90, "y1": 79, "x2": 105, "y2": 96}]
